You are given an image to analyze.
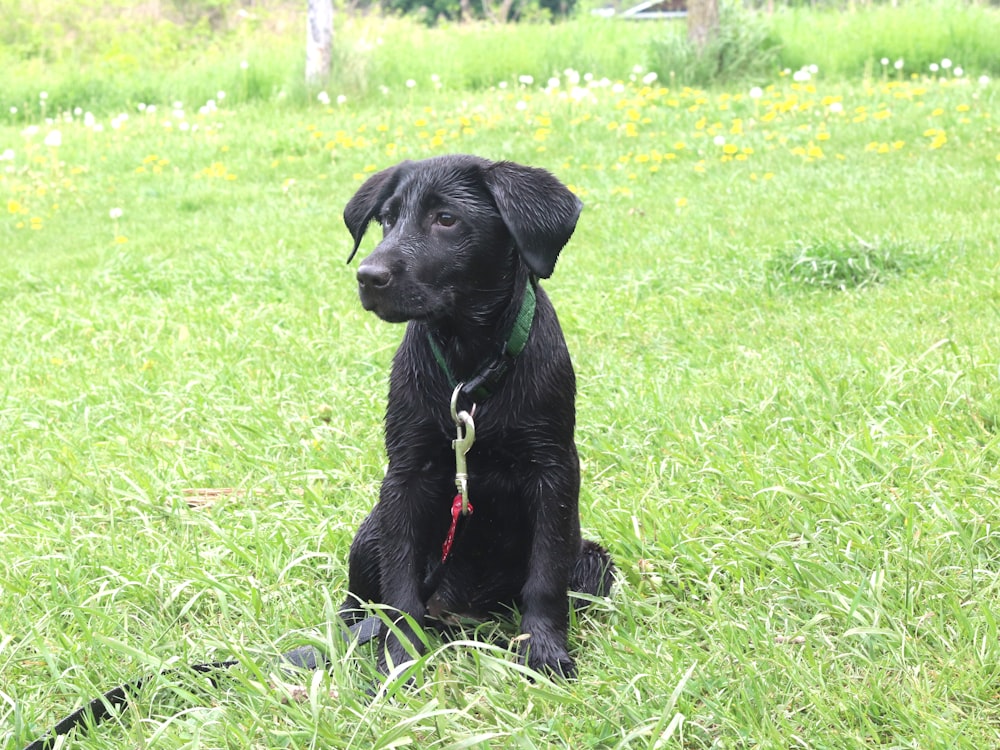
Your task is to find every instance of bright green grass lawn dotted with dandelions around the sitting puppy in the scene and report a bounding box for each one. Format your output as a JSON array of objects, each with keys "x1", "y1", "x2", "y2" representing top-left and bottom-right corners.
[{"x1": 0, "y1": 4, "x2": 1000, "y2": 750}]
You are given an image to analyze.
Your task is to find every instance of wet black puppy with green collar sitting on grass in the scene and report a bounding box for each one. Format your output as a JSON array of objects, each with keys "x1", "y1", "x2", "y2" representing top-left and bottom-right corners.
[{"x1": 341, "y1": 156, "x2": 614, "y2": 677}]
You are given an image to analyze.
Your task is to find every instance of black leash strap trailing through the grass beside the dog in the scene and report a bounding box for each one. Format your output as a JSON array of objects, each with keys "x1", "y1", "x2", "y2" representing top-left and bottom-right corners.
[{"x1": 24, "y1": 617, "x2": 382, "y2": 750}]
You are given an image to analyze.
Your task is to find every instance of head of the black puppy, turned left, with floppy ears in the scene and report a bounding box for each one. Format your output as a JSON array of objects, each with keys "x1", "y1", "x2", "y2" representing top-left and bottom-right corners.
[{"x1": 344, "y1": 155, "x2": 583, "y2": 322}]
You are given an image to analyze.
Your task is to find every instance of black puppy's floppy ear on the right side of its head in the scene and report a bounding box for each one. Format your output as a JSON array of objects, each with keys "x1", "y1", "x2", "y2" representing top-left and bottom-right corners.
[{"x1": 484, "y1": 161, "x2": 583, "y2": 279}]
